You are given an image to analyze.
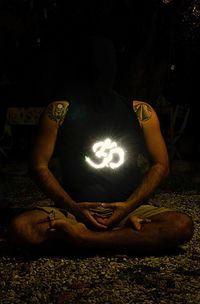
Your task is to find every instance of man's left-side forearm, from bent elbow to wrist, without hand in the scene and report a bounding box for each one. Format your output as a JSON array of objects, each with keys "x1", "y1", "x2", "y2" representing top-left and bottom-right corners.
[{"x1": 30, "y1": 167, "x2": 76, "y2": 211}]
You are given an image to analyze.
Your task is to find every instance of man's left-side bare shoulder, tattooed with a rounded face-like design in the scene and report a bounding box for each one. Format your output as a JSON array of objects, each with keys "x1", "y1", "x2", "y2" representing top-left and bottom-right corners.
[{"x1": 44, "y1": 100, "x2": 69, "y2": 126}]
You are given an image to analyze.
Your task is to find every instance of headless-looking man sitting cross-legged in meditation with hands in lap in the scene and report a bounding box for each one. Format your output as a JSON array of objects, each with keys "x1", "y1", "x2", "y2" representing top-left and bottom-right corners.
[{"x1": 9, "y1": 90, "x2": 193, "y2": 254}]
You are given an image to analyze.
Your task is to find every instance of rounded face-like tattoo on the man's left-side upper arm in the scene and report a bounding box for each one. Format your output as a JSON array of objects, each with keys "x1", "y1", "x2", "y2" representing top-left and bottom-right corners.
[{"x1": 47, "y1": 102, "x2": 67, "y2": 124}]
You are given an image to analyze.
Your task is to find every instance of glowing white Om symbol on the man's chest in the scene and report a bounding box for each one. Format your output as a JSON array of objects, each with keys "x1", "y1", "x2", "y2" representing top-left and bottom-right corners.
[{"x1": 85, "y1": 138, "x2": 124, "y2": 169}]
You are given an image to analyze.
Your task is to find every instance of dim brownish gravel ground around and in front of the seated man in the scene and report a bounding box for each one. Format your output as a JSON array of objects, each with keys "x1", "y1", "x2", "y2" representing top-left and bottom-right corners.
[{"x1": 0, "y1": 163, "x2": 200, "y2": 304}]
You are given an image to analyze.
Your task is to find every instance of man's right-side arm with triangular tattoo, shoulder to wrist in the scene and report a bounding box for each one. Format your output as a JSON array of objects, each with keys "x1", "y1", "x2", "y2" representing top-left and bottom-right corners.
[{"x1": 127, "y1": 101, "x2": 169, "y2": 210}]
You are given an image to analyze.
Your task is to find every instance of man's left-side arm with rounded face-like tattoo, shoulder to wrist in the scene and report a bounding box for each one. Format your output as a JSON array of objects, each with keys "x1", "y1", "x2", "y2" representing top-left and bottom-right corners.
[{"x1": 30, "y1": 101, "x2": 75, "y2": 210}]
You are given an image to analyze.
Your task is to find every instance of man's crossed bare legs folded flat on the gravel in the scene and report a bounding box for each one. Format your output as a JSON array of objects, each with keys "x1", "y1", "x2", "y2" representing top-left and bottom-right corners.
[{"x1": 9, "y1": 210, "x2": 193, "y2": 254}]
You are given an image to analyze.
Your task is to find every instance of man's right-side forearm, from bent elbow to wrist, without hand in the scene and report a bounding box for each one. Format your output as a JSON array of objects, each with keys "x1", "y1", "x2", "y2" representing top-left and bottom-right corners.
[{"x1": 127, "y1": 164, "x2": 168, "y2": 211}]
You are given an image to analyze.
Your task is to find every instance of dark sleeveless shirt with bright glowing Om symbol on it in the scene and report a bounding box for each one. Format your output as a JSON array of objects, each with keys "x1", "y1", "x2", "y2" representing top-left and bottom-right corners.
[{"x1": 57, "y1": 90, "x2": 149, "y2": 202}]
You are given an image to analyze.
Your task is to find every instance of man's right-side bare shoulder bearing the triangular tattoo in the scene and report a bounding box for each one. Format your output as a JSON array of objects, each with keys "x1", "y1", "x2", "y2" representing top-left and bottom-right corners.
[{"x1": 133, "y1": 100, "x2": 158, "y2": 127}]
